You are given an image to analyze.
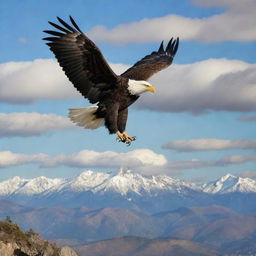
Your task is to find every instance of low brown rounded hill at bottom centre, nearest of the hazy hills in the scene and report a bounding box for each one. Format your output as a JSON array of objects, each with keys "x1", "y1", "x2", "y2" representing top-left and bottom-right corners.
[{"x1": 75, "y1": 237, "x2": 219, "y2": 256}]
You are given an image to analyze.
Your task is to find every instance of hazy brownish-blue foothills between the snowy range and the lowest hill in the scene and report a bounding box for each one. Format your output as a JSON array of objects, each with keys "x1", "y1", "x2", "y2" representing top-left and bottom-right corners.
[{"x1": 0, "y1": 201, "x2": 256, "y2": 253}]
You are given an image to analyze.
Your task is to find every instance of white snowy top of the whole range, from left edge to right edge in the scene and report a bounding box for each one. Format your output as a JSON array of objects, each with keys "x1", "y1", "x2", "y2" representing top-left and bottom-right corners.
[{"x1": 0, "y1": 169, "x2": 256, "y2": 198}]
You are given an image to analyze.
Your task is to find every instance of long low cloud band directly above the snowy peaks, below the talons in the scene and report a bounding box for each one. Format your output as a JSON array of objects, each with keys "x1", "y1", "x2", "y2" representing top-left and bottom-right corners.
[{"x1": 0, "y1": 149, "x2": 256, "y2": 174}]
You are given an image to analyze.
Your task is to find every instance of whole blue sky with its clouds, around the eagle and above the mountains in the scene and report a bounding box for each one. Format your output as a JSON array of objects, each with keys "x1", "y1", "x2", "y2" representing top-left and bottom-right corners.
[{"x1": 0, "y1": 0, "x2": 256, "y2": 181}]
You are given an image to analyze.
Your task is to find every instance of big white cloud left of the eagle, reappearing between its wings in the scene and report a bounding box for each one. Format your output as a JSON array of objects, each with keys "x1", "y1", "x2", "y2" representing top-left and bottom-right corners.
[{"x1": 0, "y1": 59, "x2": 126, "y2": 104}]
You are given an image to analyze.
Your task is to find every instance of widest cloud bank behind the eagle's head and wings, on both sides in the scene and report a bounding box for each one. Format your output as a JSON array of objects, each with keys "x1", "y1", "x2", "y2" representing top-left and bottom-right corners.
[{"x1": 0, "y1": 59, "x2": 256, "y2": 114}]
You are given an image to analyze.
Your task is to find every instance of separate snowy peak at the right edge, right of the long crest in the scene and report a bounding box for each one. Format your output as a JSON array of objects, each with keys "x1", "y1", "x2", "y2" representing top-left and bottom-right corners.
[{"x1": 202, "y1": 174, "x2": 256, "y2": 194}]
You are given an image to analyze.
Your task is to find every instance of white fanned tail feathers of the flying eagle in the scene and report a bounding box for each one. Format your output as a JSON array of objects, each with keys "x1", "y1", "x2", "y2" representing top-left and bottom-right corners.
[{"x1": 68, "y1": 106, "x2": 104, "y2": 130}]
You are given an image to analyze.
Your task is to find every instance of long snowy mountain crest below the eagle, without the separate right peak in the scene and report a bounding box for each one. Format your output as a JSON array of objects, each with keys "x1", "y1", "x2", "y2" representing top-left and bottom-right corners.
[{"x1": 0, "y1": 170, "x2": 200, "y2": 196}]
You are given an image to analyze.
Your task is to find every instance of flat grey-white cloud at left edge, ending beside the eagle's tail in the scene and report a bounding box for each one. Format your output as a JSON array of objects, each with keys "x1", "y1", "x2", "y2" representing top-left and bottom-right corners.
[{"x1": 0, "y1": 113, "x2": 75, "y2": 137}]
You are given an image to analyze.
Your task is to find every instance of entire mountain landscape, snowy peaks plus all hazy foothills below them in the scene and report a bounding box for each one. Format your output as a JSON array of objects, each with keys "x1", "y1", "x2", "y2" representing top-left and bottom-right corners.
[{"x1": 0, "y1": 170, "x2": 256, "y2": 256}]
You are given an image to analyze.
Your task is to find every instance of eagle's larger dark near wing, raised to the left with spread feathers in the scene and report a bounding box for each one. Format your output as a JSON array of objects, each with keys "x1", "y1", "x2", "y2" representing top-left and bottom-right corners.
[{"x1": 43, "y1": 16, "x2": 117, "y2": 103}]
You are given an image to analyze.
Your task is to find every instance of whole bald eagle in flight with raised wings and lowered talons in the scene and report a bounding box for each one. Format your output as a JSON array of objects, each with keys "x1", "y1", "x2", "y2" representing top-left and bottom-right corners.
[{"x1": 43, "y1": 16, "x2": 179, "y2": 144}]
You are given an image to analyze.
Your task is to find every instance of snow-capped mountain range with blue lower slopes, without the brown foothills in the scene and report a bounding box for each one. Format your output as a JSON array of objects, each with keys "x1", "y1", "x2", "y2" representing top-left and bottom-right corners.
[{"x1": 0, "y1": 170, "x2": 256, "y2": 214}]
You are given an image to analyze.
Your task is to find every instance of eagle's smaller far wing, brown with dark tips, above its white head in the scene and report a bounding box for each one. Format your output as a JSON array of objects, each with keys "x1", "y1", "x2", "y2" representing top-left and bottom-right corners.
[{"x1": 121, "y1": 38, "x2": 179, "y2": 80}]
